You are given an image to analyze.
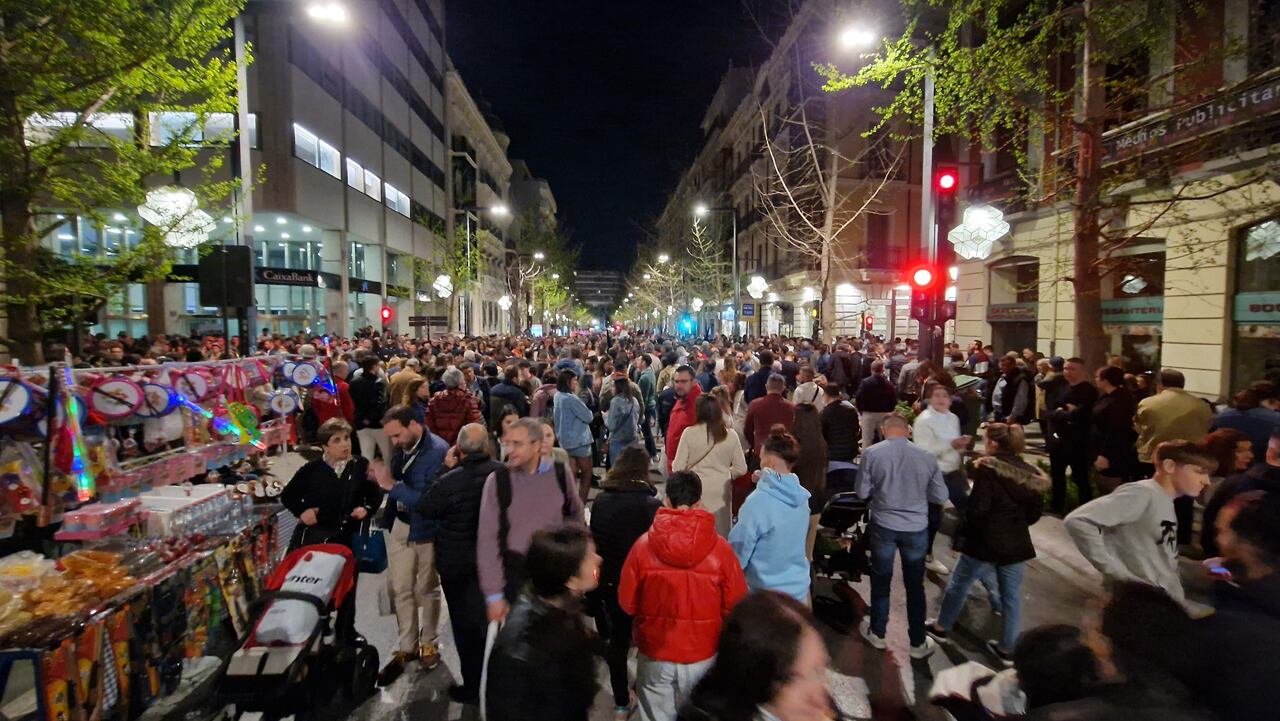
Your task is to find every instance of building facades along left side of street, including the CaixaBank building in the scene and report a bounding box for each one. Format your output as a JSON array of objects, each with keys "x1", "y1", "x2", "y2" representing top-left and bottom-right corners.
[{"x1": 29, "y1": 0, "x2": 556, "y2": 345}]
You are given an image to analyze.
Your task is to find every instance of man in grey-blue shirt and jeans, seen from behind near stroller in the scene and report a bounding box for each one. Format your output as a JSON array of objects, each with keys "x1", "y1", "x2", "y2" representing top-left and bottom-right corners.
[{"x1": 858, "y1": 414, "x2": 947, "y2": 658}]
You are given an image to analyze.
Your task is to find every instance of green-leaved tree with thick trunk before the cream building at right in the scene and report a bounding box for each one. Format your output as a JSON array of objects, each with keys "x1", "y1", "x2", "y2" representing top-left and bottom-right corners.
[{"x1": 819, "y1": 0, "x2": 1274, "y2": 366}]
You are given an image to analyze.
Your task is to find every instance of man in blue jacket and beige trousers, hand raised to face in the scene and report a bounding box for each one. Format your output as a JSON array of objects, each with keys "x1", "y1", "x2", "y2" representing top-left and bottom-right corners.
[{"x1": 370, "y1": 405, "x2": 449, "y2": 686}]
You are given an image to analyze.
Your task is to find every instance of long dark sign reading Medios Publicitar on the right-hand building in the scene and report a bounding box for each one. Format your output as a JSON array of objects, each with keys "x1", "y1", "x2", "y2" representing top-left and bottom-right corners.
[{"x1": 1102, "y1": 78, "x2": 1280, "y2": 161}]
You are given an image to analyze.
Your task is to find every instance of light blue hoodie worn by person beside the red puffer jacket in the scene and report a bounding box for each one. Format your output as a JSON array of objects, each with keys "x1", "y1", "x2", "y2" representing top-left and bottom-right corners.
[{"x1": 728, "y1": 469, "x2": 810, "y2": 602}]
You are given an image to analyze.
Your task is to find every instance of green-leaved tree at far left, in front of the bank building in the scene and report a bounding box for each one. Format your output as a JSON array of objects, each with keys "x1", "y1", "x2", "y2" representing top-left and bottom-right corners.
[{"x1": 0, "y1": 0, "x2": 244, "y2": 364}]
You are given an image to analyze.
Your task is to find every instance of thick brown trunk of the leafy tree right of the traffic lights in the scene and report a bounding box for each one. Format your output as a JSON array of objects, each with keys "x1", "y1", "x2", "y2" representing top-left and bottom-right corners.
[{"x1": 1070, "y1": 0, "x2": 1107, "y2": 369}]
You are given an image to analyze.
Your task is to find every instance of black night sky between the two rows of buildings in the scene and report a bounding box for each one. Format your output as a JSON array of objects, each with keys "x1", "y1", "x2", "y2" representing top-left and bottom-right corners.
[{"x1": 445, "y1": 0, "x2": 767, "y2": 270}]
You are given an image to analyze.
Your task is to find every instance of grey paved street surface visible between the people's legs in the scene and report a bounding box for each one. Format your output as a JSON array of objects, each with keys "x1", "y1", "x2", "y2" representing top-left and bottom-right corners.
[{"x1": 262, "y1": 450, "x2": 1203, "y2": 721}]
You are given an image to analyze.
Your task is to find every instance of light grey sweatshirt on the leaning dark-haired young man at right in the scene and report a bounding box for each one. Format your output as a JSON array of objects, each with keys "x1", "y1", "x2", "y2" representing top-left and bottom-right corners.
[{"x1": 1065, "y1": 479, "x2": 1185, "y2": 603}]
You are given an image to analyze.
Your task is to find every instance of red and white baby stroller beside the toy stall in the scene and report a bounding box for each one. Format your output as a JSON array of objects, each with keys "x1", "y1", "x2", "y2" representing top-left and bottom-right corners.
[{"x1": 220, "y1": 543, "x2": 378, "y2": 721}]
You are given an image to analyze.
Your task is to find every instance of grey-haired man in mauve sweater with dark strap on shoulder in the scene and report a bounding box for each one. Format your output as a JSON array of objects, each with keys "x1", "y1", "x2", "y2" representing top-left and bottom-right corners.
[{"x1": 476, "y1": 417, "x2": 582, "y2": 621}]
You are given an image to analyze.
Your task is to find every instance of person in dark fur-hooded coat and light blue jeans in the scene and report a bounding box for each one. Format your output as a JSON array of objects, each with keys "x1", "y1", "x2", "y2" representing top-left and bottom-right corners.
[{"x1": 927, "y1": 423, "x2": 1050, "y2": 665}]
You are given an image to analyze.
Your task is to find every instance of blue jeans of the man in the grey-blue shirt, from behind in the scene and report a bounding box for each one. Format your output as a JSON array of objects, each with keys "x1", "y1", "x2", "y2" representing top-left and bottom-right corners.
[{"x1": 870, "y1": 521, "x2": 929, "y2": 645}]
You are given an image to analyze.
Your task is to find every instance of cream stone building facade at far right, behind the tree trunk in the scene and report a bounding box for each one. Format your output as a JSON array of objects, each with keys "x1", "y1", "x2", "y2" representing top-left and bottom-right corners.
[{"x1": 957, "y1": 0, "x2": 1280, "y2": 400}]
